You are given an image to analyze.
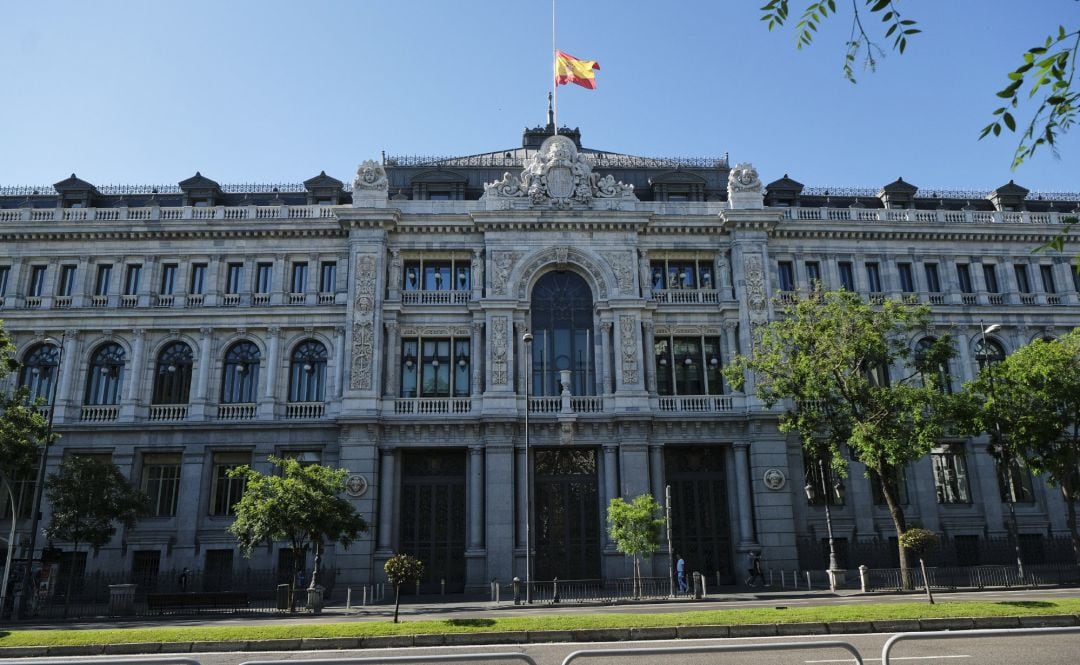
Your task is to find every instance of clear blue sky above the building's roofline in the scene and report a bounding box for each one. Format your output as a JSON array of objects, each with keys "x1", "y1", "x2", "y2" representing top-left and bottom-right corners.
[{"x1": 0, "y1": 0, "x2": 1080, "y2": 192}]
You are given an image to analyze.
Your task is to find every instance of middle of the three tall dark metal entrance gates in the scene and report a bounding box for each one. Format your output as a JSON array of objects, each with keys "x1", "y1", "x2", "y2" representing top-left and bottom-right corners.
[{"x1": 532, "y1": 448, "x2": 600, "y2": 580}]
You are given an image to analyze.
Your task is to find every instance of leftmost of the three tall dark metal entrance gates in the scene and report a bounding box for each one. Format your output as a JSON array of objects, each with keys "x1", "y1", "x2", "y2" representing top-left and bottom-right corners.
[{"x1": 399, "y1": 450, "x2": 465, "y2": 594}]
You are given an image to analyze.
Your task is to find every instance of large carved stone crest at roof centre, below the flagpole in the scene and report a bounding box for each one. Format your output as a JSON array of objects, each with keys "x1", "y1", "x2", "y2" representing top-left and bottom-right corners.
[{"x1": 484, "y1": 135, "x2": 637, "y2": 208}]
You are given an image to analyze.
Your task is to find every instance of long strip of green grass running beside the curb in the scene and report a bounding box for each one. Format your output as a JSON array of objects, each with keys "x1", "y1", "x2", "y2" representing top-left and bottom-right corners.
[{"x1": 0, "y1": 598, "x2": 1080, "y2": 647}]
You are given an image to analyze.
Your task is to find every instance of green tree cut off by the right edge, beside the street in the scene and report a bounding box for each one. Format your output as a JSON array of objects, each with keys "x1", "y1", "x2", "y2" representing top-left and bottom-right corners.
[{"x1": 964, "y1": 328, "x2": 1080, "y2": 565}]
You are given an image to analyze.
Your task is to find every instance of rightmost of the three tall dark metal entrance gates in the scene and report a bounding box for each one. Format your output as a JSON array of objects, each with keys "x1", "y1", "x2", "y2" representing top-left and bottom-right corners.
[{"x1": 664, "y1": 446, "x2": 738, "y2": 584}]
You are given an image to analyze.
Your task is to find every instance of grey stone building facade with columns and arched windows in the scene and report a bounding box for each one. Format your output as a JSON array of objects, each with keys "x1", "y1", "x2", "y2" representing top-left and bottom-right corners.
[{"x1": 0, "y1": 124, "x2": 1080, "y2": 591}]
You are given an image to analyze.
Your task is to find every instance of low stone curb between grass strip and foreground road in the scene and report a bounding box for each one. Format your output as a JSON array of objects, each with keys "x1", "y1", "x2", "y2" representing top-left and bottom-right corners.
[{"x1": 6, "y1": 614, "x2": 1080, "y2": 659}]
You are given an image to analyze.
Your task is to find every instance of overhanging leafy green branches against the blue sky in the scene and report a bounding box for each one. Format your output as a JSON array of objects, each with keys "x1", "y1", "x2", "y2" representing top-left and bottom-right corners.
[{"x1": 761, "y1": 0, "x2": 1080, "y2": 169}]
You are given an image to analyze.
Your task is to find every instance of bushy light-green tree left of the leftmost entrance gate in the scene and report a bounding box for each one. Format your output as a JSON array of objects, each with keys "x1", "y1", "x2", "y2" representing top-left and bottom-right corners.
[{"x1": 228, "y1": 457, "x2": 367, "y2": 610}]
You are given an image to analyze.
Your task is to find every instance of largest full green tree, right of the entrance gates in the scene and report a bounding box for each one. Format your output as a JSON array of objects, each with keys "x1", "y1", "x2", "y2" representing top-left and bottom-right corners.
[{"x1": 725, "y1": 290, "x2": 953, "y2": 582}]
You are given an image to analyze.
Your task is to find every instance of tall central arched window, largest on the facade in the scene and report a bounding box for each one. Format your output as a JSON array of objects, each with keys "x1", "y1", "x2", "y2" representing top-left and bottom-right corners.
[{"x1": 530, "y1": 270, "x2": 596, "y2": 395}]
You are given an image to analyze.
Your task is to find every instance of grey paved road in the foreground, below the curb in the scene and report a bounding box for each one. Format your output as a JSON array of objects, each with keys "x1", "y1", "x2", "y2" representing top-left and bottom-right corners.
[{"x1": 8, "y1": 634, "x2": 1080, "y2": 665}]
